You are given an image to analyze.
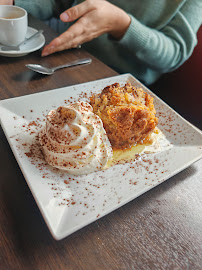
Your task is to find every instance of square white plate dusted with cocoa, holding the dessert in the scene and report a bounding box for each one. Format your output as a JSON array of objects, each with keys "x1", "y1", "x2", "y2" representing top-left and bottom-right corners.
[{"x1": 0, "y1": 74, "x2": 202, "y2": 240}]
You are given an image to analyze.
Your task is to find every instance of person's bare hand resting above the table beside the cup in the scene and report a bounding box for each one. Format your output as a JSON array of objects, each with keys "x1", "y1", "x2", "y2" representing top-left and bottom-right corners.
[{"x1": 42, "y1": 0, "x2": 130, "y2": 56}]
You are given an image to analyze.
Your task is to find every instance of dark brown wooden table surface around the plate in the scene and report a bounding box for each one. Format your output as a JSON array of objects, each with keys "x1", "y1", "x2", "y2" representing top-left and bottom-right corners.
[{"x1": 0, "y1": 15, "x2": 202, "y2": 270}]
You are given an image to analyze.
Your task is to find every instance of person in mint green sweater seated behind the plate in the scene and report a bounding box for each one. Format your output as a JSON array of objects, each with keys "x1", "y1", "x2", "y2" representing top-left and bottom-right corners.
[{"x1": 0, "y1": 0, "x2": 202, "y2": 84}]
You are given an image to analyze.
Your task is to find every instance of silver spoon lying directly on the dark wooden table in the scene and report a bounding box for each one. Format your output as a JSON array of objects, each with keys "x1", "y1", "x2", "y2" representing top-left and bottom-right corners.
[{"x1": 26, "y1": 58, "x2": 92, "y2": 75}]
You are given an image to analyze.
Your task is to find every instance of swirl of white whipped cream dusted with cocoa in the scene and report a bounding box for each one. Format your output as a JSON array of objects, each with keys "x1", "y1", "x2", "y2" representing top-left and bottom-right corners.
[{"x1": 39, "y1": 101, "x2": 112, "y2": 175}]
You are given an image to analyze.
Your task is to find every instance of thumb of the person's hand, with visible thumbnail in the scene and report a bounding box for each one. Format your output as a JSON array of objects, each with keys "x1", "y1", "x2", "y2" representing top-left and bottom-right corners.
[{"x1": 60, "y1": 1, "x2": 92, "y2": 22}]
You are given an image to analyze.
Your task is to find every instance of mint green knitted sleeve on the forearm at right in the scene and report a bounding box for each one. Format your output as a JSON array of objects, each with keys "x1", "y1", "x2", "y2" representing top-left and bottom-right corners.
[{"x1": 117, "y1": 0, "x2": 202, "y2": 73}]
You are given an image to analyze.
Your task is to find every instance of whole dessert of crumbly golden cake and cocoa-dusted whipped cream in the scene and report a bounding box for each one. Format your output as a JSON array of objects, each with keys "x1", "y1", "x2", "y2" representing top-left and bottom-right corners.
[{"x1": 39, "y1": 83, "x2": 160, "y2": 175}]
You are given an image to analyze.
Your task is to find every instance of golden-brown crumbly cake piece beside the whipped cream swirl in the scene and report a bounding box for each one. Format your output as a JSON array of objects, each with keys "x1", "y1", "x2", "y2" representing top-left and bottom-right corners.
[{"x1": 90, "y1": 83, "x2": 158, "y2": 149}]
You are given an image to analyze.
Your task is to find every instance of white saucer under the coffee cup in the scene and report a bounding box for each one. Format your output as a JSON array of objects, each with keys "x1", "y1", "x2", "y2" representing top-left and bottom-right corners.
[{"x1": 0, "y1": 27, "x2": 45, "y2": 57}]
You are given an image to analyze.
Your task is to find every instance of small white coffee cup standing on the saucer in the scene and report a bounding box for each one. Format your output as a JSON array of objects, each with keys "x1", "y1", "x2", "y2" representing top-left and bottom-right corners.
[{"x1": 0, "y1": 5, "x2": 28, "y2": 46}]
